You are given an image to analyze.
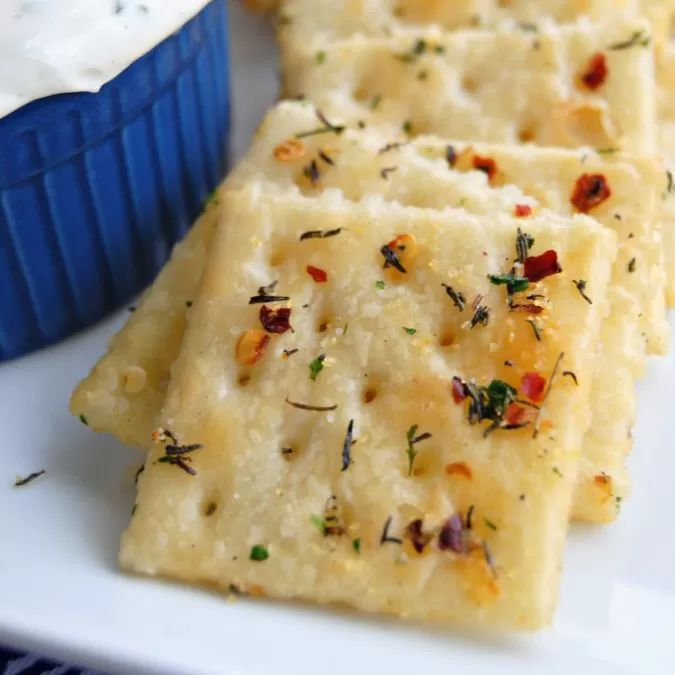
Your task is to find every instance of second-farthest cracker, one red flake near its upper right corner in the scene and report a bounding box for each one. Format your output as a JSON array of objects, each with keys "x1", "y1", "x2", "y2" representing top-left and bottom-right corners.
[{"x1": 282, "y1": 20, "x2": 655, "y2": 152}]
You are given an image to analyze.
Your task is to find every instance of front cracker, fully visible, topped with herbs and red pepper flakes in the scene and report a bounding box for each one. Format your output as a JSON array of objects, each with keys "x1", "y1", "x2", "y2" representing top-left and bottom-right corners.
[{"x1": 120, "y1": 185, "x2": 616, "y2": 628}]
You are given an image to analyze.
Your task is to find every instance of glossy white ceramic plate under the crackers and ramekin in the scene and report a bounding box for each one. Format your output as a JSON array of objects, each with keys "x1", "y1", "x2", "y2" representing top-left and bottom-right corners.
[{"x1": 0, "y1": 3, "x2": 675, "y2": 675}]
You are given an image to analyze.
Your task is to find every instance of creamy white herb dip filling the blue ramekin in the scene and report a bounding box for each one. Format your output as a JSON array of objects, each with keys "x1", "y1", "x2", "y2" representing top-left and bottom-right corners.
[{"x1": 0, "y1": 0, "x2": 208, "y2": 117}]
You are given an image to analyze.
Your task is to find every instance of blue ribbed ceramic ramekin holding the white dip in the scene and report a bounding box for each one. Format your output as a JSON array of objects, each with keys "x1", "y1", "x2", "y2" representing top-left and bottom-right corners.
[{"x1": 0, "y1": 0, "x2": 230, "y2": 361}]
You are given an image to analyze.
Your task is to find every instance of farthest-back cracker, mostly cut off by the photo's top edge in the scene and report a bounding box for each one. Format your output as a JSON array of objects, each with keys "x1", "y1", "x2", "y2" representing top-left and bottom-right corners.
[{"x1": 279, "y1": 0, "x2": 642, "y2": 48}]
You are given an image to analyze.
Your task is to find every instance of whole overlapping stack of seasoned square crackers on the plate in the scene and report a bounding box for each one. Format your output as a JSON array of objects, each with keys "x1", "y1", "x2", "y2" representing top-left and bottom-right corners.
[{"x1": 71, "y1": 0, "x2": 675, "y2": 628}]
